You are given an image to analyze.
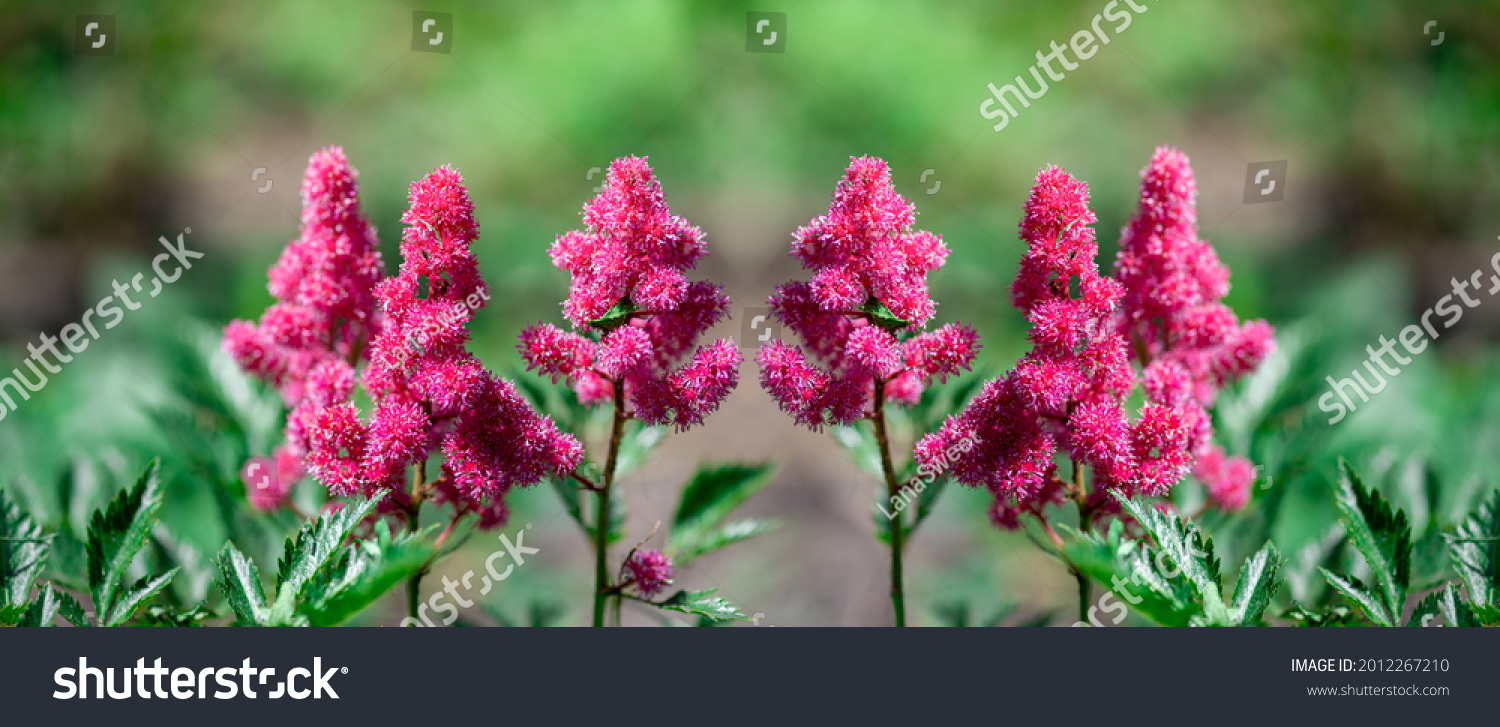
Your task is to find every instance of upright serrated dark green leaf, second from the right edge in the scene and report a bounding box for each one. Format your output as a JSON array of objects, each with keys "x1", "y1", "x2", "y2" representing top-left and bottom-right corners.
[{"x1": 1329, "y1": 459, "x2": 1412, "y2": 627}]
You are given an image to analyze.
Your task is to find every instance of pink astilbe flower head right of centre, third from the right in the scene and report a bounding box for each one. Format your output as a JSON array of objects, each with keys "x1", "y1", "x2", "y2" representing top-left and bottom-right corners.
[{"x1": 758, "y1": 156, "x2": 980, "y2": 430}]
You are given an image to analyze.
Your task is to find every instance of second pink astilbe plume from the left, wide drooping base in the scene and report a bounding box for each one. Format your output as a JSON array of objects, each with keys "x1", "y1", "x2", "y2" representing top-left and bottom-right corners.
[{"x1": 303, "y1": 166, "x2": 584, "y2": 528}]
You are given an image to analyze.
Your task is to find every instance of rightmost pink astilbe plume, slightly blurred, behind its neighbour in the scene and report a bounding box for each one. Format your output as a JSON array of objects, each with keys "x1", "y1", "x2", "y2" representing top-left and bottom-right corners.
[{"x1": 1115, "y1": 147, "x2": 1277, "y2": 510}]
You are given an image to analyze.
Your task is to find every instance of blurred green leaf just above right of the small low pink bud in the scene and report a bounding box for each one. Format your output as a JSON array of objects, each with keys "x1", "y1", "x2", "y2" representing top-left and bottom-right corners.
[{"x1": 668, "y1": 462, "x2": 776, "y2": 568}]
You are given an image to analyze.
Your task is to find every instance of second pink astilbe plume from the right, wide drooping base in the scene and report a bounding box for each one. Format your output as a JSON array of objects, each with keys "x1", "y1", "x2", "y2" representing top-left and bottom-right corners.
[{"x1": 915, "y1": 166, "x2": 1190, "y2": 528}]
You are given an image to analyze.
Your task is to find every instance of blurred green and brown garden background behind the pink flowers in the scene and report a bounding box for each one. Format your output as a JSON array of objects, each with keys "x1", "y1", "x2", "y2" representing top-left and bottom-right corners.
[{"x1": 0, "y1": 0, "x2": 1500, "y2": 625}]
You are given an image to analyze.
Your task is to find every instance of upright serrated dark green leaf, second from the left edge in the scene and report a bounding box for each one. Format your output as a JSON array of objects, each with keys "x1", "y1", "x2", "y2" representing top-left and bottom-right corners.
[{"x1": 89, "y1": 459, "x2": 171, "y2": 625}]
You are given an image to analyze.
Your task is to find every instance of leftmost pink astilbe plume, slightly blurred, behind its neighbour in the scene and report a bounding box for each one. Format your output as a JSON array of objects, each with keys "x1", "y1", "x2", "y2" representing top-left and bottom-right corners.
[{"x1": 224, "y1": 147, "x2": 384, "y2": 510}]
